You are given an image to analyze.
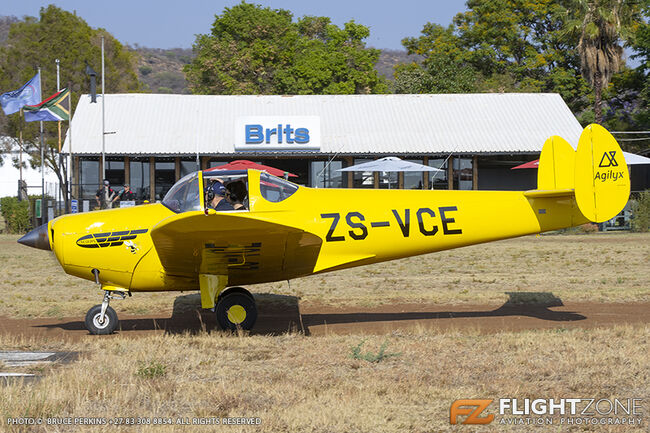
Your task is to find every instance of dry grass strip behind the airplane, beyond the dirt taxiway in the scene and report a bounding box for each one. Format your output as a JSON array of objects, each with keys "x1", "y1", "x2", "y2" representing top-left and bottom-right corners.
[{"x1": 0, "y1": 233, "x2": 650, "y2": 318}]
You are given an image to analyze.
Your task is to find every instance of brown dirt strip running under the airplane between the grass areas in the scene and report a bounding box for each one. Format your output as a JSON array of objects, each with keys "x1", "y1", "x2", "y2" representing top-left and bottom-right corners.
[{"x1": 0, "y1": 298, "x2": 650, "y2": 340}]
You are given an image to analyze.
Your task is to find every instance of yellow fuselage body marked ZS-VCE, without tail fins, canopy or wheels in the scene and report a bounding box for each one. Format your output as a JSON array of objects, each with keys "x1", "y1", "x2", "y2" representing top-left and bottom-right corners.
[{"x1": 50, "y1": 182, "x2": 586, "y2": 291}]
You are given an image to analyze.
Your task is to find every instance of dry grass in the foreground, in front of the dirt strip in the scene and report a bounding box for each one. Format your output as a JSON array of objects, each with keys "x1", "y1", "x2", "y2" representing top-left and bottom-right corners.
[{"x1": 0, "y1": 326, "x2": 650, "y2": 432}]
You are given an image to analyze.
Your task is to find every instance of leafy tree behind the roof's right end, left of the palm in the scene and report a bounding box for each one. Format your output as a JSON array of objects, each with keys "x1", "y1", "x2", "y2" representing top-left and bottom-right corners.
[{"x1": 396, "y1": 0, "x2": 588, "y2": 111}]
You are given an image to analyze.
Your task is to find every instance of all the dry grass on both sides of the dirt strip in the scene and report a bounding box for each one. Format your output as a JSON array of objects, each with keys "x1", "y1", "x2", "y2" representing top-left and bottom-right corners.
[{"x1": 0, "y1": 233, "x2": 650, "y2": 432}]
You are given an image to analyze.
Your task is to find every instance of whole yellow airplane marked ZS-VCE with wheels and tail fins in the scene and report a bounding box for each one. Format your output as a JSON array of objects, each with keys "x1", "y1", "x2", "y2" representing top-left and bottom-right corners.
[{"x1": 18, "y1": 125, "x2": 630, "y2": 334}]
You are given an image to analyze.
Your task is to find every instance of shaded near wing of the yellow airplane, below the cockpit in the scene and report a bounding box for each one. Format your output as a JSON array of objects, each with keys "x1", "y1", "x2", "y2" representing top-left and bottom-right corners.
[{"x1": 151, "y1": 211, "x2": 322, "y2": 285}]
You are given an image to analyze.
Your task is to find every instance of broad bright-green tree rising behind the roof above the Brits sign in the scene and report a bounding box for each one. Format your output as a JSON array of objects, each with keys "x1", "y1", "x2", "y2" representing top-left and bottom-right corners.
[{"x1": 184, "y1": 2, "x2": 386, "y2": 94}]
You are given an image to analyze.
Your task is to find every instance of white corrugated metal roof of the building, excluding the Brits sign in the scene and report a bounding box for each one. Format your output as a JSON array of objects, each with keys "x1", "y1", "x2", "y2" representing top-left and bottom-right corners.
[{"x1": 65, "y1": 93, "x2": 582, "y2": 155}]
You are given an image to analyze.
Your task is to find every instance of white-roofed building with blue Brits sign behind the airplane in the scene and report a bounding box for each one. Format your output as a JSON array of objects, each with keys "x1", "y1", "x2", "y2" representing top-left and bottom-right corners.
[{"x1": 64, "y1": 93, "x2": 582, "y2": 201}]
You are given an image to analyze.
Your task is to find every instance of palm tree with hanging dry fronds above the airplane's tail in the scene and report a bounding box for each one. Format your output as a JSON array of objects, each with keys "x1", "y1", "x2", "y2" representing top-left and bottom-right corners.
[{"x1": 570, "y1": 0, "x2": 641, "y2": 123}]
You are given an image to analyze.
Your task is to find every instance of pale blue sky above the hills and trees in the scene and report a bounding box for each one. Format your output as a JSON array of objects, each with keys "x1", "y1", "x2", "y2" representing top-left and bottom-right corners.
[{"x1": 0, "y1": 0, "x2": 466, "y2": 50}]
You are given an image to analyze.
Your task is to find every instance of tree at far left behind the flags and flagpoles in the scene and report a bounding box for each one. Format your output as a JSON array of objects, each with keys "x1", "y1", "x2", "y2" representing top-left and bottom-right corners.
[{"x1": 0, "y1": 5, "x2": 139, "y2": 206}]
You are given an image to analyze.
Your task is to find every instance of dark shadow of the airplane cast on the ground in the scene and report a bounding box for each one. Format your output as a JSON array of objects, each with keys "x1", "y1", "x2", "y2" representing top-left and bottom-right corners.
[{"x1": 35, "y1": 292, "x2": 586, "y2": 335}]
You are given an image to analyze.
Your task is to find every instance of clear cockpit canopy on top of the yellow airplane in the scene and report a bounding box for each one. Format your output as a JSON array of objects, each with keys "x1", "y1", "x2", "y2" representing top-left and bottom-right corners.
[{"x1": 162, "y1": 170, "x2": 299, "y2": 213}]
